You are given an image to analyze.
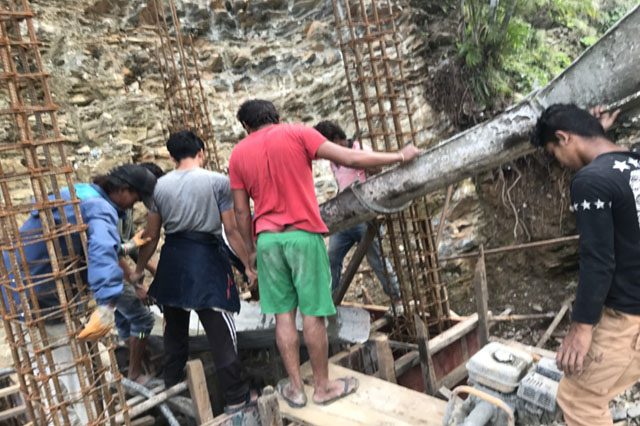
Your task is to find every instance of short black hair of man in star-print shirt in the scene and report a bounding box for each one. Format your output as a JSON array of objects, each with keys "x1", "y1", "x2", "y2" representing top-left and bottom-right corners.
[{"x1": 530, "y1": 104, "x2": 606, "y2": 148}]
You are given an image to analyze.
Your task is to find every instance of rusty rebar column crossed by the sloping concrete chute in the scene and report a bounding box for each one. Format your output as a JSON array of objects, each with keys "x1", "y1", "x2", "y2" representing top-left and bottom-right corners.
[{"x1": 333, "y1": 0, "x2": 449, "y2": 337}]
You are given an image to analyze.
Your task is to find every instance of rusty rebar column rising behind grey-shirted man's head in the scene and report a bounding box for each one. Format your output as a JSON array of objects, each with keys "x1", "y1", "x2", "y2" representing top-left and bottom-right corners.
[{"x1": 152, "y1": 0, "x2": 221, "y2": 171}]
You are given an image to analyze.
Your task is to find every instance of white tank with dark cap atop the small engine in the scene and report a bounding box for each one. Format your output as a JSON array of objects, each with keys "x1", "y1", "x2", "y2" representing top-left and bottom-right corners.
[{"x1": 466, "y1": 342, "x2": 533, "y2": 393}]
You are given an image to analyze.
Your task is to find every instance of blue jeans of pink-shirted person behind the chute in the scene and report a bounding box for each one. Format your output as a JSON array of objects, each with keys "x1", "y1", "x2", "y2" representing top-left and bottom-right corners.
[{"x1": 329, "y1": 223, "x2": 400, "y2": 299}]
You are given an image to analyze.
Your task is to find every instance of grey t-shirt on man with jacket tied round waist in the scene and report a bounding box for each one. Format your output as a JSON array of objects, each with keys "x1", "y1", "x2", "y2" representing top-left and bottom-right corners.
[{"x1": 153, "y1": 168, "x2": 233, "y2": 235}]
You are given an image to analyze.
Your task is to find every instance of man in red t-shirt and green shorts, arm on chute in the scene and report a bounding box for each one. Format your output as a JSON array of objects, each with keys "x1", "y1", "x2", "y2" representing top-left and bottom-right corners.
[{"x1": 229, "y1": 100, "x2": 420, "y2": 407}]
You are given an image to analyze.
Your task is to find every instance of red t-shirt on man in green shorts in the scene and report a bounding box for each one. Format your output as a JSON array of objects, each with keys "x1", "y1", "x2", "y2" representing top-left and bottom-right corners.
[{"x1": 229, "y1": 124, "x2": 327, "y2": 233}]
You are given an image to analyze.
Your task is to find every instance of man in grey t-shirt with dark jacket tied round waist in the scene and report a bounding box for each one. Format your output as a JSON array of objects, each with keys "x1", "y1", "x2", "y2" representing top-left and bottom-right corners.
[{"x1": 133, "y1": 131, "x2": 255, "y2": 412}]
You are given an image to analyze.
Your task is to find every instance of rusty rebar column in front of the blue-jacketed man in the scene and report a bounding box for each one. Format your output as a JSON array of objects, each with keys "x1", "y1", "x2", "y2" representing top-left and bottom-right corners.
[{"x1": 0, "y1": 0, "x2": 129, "y2": 426}]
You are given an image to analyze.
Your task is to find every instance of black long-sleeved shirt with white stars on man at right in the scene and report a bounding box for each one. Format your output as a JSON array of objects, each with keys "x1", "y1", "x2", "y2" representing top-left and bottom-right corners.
[{"x1": 571, "y1": 152, "x2": 640, "y2": 323}]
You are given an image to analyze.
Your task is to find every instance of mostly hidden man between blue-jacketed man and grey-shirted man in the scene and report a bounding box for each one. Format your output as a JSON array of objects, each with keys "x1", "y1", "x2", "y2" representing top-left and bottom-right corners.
[{"x1": 115, "y1": 163, "x2": 164, "y2": 385}]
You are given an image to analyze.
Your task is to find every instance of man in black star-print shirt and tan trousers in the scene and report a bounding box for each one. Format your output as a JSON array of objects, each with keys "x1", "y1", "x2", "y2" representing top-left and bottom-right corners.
[{"x1": 531, "y1": 104, "x2": 640, "y2": 426}]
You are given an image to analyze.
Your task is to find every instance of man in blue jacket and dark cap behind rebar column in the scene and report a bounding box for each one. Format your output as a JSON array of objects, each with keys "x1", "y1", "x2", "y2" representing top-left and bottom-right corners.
[{"x1": 3, "y1": 165, "x2": 156, "y2": 425}]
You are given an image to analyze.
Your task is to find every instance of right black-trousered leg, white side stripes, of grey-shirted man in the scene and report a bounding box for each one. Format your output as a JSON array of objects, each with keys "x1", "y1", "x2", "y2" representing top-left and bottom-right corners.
[{"x1": 197, "y1": 309, "x2": 249, "y2": 405}]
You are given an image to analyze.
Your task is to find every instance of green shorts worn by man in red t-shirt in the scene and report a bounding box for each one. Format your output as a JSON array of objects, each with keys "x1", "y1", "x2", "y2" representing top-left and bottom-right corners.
[{"x1": 257, "y1": 231, "x2": 336, "y2": 317}]
